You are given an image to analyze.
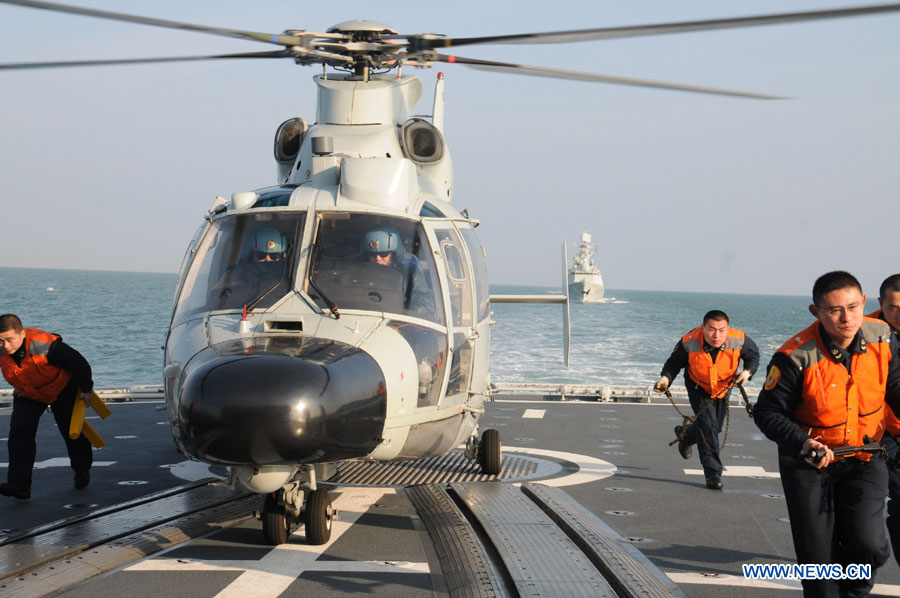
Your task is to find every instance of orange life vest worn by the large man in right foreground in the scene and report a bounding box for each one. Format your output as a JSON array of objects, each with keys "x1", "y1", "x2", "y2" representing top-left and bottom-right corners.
[{"x1": 778, "y1": 318, "x2": 891, "y2": 461}]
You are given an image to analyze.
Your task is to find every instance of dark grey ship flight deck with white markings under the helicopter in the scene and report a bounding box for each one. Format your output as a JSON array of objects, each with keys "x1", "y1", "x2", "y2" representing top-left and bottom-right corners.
[{"x1": 0, "y1": 385, "x2": 900, "y2": 598}]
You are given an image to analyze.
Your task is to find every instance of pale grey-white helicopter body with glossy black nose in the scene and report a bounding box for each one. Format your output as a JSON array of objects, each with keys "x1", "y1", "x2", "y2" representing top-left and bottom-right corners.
[{"x1": 164, "y1": 76, "x2": 490, "y2": 492}]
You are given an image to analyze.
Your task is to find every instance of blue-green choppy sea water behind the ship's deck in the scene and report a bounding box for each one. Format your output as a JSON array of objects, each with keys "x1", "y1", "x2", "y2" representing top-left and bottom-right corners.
[{"x1": 0, "y1": 268, "x2": 877, "y2": 388}]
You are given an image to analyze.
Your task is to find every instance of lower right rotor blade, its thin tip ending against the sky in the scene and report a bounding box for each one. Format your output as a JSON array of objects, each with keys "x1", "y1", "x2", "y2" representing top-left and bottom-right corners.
[{"x1": 433, "y1": 54, "x2": 787, "y2": 100}]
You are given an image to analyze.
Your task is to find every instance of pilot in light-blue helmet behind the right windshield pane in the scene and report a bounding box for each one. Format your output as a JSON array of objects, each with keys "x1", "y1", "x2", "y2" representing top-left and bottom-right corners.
[{"x1": 362, "y1": 225, "x2": 434, "y2": 317}]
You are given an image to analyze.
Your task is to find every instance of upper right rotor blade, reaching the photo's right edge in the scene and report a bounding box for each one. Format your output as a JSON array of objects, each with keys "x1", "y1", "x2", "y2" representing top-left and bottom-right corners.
[{"x1": 410, "y1": 4, "x2": 900, "y2": 53}]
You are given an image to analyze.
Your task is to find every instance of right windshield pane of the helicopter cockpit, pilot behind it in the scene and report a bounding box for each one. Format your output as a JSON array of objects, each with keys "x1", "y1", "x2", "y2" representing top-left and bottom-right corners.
[{"x1": 308, "y1": 212, "x2": 444, "y2": 324}]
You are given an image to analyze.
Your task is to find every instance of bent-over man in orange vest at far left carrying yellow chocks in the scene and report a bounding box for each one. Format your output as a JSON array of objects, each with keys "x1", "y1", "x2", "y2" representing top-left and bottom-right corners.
[{"x1": 0, "y1": 314, "x2": 94, "y2": 500}]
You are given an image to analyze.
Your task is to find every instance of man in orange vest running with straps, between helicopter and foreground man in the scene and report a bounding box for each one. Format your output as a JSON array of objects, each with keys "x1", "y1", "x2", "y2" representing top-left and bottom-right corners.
[{"x1": 653, "y1": 309, "x2": 759, "y2": 490}]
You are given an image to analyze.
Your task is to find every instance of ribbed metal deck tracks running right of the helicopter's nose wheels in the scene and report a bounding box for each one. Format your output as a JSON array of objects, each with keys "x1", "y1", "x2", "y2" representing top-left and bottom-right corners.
[{"x1": 406, "y1": 483, "x2": 685, "y2": 597}]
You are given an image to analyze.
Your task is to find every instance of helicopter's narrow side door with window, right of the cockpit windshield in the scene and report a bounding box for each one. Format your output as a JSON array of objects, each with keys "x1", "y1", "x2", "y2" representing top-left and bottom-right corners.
[{"x1": 426, "y1": 221, "x2": 477, "y2": 407}]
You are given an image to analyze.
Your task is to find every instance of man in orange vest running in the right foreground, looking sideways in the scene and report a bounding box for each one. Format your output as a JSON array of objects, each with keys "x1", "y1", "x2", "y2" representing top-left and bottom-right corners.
[{"x1": 753, "y1": 271, "x2": 900, "y2": 596}]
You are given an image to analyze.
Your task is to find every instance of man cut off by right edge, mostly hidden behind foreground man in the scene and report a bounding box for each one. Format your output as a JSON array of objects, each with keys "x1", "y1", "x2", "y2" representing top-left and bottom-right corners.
[{"x1": 866, "y1": 274, "x2": 900, "y2": 563}]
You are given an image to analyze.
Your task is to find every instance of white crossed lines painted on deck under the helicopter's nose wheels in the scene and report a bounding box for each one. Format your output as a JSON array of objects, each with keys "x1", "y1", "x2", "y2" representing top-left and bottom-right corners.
[{"x1": 124, "y1": 488, "x2": 431, "y2": 598}]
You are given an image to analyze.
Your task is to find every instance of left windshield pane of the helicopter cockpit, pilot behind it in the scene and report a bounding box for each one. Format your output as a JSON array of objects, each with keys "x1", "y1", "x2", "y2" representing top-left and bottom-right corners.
[{"x1": 175, "y1": 212, "x2": 305, "y2": 321}]
